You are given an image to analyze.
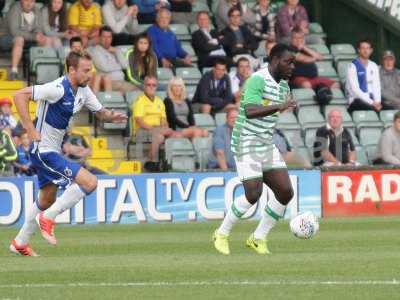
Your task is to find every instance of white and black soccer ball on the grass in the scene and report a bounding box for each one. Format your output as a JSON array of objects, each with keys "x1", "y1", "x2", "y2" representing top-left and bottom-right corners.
[{"x1": 290, "y1": 211, "x2": 319, "y2": 239}]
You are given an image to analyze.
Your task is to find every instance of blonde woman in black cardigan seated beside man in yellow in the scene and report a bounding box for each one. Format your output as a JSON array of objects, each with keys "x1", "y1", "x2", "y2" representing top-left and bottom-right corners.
[{"x1": 164, "y1": 77, "x2": 208, "y2": 138}]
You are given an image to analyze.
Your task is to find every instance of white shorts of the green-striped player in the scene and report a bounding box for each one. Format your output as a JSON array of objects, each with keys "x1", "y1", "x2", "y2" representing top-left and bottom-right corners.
[{"x1": 235, "y1": 145, "x2": 286, "y2": 181}]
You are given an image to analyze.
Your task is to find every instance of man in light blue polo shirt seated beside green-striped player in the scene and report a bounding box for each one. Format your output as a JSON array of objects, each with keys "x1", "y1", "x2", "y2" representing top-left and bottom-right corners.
[{"x1": 208, "y1": 108, "x2": 238, "y2": 170}]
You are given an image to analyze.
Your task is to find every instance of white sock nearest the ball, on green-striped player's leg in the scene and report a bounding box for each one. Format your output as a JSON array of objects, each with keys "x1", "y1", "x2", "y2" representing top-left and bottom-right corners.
[{"x1": 254, "y1": 198, "x2": 286, "y2": 240}]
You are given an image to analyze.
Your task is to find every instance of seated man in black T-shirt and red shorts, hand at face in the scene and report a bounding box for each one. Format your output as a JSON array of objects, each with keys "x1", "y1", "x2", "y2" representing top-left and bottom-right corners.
[{"x1": 290, "y1": 28, "x2": 340, "y2": 89}]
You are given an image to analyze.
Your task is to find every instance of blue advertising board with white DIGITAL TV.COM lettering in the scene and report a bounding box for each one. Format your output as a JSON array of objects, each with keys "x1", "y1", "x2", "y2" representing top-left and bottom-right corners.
[{"x1": 0, "y1": 170, "x2": 321, "y2": 226}]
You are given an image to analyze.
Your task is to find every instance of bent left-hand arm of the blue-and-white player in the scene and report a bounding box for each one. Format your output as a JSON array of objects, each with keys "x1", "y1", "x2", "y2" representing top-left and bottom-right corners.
[{"x1": 14, "y1": 86, "x2": 40, "y2": 141}]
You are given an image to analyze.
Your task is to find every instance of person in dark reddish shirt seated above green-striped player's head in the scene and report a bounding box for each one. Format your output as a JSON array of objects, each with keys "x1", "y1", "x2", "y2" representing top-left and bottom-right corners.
[{"x1": 276, "y1": 0, "x2": 321, "y2": 44}]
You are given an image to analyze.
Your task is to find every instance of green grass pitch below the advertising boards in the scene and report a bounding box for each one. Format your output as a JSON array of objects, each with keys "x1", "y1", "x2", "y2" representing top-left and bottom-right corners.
[{"x1": 0, "y1": 217, "x2": 400, "y2": 300}]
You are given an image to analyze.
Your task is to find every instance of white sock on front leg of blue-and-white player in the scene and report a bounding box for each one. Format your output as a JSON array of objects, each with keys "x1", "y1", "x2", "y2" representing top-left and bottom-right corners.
[{"x1": 43, "y1": 183, "x2": 86, "y2": 221}]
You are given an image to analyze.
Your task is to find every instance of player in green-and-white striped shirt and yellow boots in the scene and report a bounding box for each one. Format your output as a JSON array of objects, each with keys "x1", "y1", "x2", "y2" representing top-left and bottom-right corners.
[{"x1": 213, "y1": 44, "x2": 296, "y2": 255}]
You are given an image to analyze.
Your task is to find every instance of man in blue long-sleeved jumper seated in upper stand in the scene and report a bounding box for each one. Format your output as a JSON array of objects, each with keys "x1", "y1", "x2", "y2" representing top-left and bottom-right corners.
[{"x1": 147, "y1": 8, "x2": 192, "y2": 68}]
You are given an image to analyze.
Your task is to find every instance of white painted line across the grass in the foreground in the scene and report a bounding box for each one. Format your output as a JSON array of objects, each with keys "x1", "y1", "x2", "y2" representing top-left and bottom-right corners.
[{"x1": 0, "y1": 279, "x2": 400, "y2": 289}]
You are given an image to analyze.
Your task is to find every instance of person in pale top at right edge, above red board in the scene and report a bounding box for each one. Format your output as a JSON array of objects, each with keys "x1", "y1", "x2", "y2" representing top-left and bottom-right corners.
[{"x1": 374, "y1": 111, "x2": 400, "y2": 166}]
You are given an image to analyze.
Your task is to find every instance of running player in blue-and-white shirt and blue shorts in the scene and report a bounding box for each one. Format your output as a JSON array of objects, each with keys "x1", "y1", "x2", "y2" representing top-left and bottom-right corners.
[{"x1": 10, "y1": 52, "x2": 127, "y2": 256}]
